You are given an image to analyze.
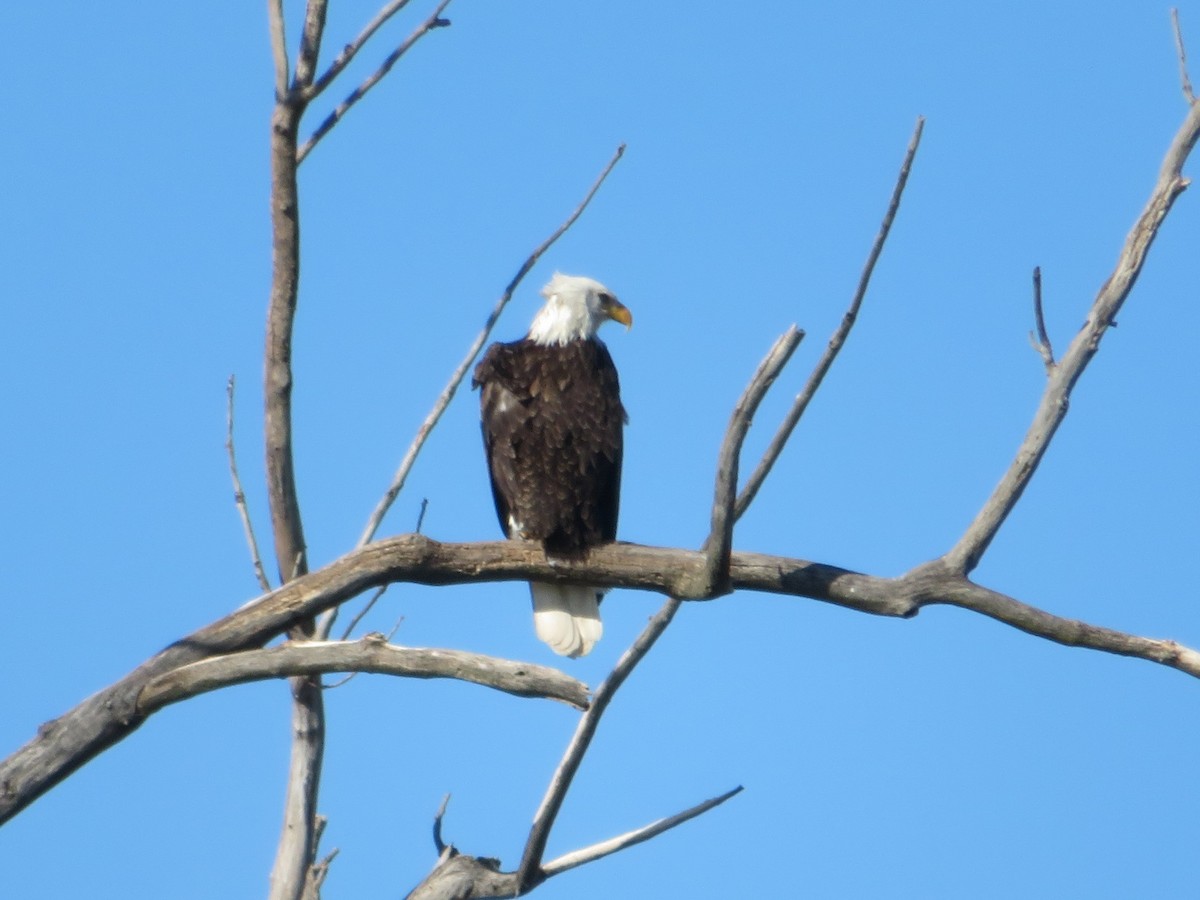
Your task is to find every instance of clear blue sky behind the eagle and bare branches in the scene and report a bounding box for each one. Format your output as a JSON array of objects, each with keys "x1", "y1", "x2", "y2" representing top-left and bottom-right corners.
[{"x1": 0, "y1": 0, "x2": 1200, "y2": 900}]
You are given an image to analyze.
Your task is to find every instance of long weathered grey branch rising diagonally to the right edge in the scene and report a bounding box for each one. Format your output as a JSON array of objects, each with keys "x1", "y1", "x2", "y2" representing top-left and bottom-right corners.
[{"x1": 944, "y1": 102, "x2": 1200, "y2": 575}]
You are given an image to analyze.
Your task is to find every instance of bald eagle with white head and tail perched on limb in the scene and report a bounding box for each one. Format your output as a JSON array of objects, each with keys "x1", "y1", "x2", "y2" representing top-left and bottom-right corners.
[{"x1": 472, "y1": 272, "x2": 634, "y2": 656}]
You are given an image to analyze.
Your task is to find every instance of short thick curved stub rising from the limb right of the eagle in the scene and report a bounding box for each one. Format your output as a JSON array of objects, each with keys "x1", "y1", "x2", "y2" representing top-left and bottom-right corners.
[{"x1": 702, "y1": 325, "x2": 804, "y2": 594}]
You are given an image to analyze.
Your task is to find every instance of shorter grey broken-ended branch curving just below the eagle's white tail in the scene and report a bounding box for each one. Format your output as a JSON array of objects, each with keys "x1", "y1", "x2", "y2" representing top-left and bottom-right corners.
[{"x1": 138, "y1": 635, "x2": 588, "y2": 715}]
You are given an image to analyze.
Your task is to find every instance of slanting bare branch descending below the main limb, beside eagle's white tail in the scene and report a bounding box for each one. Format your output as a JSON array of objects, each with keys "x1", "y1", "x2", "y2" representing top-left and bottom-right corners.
[{"x1": 517, "y1": 598, "x2": 683, "y2": 894}]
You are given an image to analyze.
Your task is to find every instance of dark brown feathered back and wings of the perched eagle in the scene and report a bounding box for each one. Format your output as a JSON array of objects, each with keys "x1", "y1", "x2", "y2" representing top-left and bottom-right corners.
[{"x1": 473, "y1": 338, "x2": 625, "y2": 556}]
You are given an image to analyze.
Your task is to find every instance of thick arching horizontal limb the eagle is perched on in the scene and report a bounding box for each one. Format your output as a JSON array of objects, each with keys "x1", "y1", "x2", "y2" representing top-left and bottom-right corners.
[{"x1": 0, "y1": 534, "x2": 1200, "y2": 822}]
